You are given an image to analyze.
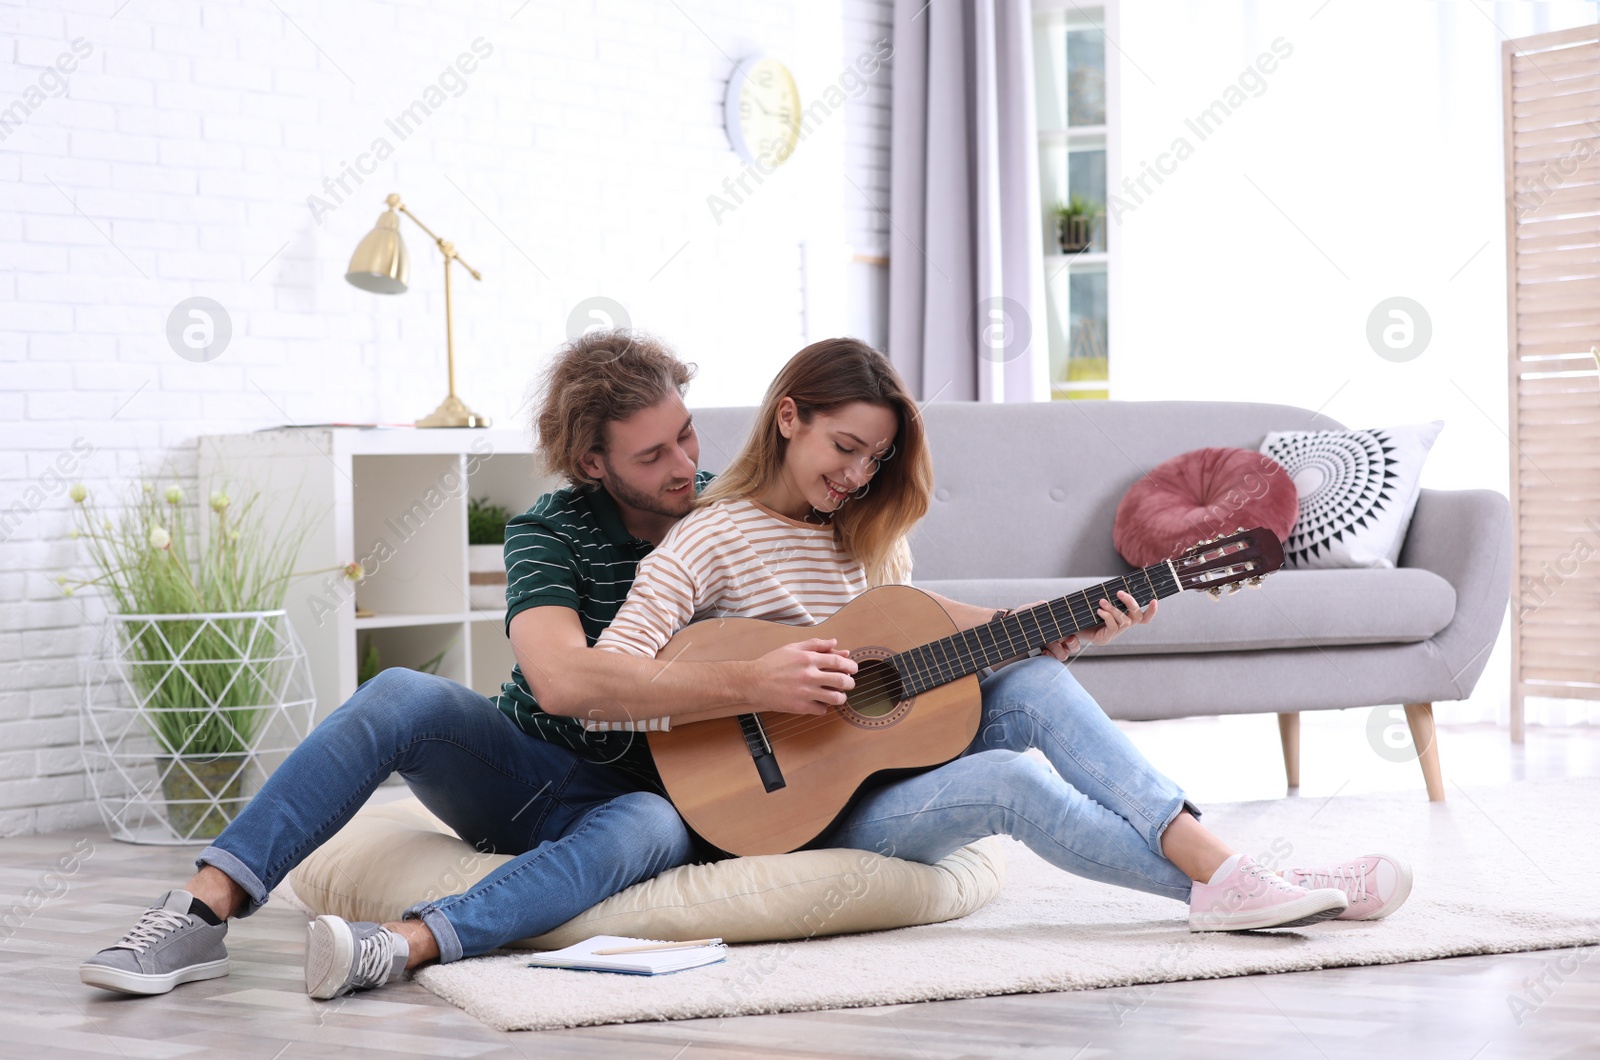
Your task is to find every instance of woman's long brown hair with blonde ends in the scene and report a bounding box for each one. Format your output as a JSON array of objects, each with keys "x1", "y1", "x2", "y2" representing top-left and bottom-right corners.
[{"x1": 696, "y1": 338, "x2": 933, "y2": 586}]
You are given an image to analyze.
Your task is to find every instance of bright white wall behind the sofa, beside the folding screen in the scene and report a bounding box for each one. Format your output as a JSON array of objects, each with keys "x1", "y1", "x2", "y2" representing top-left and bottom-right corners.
[{"x1": 1107, "y1": 0, "x2": 1600, "y2": 721}]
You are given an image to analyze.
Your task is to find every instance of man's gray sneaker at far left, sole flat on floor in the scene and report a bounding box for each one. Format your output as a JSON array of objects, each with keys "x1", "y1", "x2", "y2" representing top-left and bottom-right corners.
[{"x1": 78, "y1": 890, "x2": 227, "y2": 994}]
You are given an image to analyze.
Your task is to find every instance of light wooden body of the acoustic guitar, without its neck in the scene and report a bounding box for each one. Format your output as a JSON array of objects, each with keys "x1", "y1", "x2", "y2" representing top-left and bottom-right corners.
[{"x1": 650, "y1": 584, "x2": 982, "y2": 855}]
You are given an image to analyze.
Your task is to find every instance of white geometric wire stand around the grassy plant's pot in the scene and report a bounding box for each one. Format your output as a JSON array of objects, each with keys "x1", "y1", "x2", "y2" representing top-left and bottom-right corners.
[{"x1": 78, "y1": 610, "x2": 317, "y2": 845}]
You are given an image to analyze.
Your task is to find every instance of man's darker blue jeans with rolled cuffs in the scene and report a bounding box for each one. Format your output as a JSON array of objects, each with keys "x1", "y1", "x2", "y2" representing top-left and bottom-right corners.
[{"x1": 195, "y1": 669, "x2": 693, "y2": 961}]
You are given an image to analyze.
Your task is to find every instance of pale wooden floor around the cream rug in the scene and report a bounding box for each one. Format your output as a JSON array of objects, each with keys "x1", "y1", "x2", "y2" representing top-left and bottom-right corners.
[{"x1": 0, "y1": 713, "x2": 1600, "y2": 1060}]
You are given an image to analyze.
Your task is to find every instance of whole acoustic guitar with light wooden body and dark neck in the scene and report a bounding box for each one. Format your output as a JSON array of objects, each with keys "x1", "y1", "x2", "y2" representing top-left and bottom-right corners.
[{"x1": 650, "y1": 528, "x2": 1283, "y2": 855}]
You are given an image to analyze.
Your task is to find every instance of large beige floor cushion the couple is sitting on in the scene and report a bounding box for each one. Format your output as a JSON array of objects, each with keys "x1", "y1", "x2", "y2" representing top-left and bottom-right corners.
[{"x1": 290, "y1": 799, "x2": 1005, "y2": 950}]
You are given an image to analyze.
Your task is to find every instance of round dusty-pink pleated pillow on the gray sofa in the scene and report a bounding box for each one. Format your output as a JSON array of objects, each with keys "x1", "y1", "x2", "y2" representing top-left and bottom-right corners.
[{"x1": 1110, "y1": 448, "x2": 1299, "y2": 567}]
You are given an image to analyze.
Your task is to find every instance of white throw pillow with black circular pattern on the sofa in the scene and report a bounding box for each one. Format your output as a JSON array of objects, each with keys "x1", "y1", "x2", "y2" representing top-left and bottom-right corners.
[{"x1": 1261, "y1": 420, "x2": 1445, "y2": 567}]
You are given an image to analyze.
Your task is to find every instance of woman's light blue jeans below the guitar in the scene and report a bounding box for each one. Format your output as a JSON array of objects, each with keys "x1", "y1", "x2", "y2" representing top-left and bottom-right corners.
[{"x1": 818, "y1": 655, "x2": 1198, "y2": 901}]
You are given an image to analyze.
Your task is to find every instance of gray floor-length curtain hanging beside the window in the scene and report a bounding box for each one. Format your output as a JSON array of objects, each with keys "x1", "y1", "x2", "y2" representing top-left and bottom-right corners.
[{"x1": 888, "y1": 0, "x2": 1050, "y2": 402}]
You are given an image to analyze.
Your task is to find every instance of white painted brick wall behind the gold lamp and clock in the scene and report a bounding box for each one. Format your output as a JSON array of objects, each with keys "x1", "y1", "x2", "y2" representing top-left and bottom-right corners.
[{"x1": 0, "y1": 0, "x2": 890, "y2": 836}]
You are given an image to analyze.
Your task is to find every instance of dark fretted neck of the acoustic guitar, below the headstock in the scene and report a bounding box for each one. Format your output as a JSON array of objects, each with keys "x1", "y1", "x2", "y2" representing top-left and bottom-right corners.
[{"x1": 890, "y1": 560, "x2": 1182, "y2": 695}]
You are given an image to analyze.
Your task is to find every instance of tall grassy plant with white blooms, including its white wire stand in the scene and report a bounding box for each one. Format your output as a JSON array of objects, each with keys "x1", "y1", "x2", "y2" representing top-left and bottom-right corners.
[{"x1": 59, "y1": 482, "x2": 362, "y2": 842}]
